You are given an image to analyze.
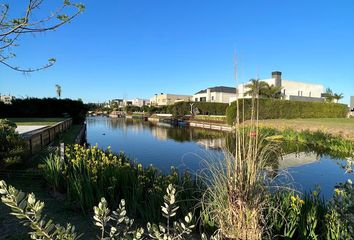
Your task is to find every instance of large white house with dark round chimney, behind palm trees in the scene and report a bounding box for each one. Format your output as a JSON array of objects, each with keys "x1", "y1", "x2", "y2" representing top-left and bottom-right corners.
[{"x1": 237, "y1": 71, "x2": 324, "y2": 102}]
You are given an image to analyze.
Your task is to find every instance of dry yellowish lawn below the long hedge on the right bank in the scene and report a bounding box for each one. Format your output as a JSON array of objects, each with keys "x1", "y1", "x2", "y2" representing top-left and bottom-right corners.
[{"x1": 254, "y1": 118, "x2": 354, "y2": 140}]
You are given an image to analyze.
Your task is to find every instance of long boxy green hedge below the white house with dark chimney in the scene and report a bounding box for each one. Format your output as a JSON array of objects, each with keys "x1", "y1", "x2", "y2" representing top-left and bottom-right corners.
[{"x1": 226, "y1": 99, "x2": 348, "y2": 125}]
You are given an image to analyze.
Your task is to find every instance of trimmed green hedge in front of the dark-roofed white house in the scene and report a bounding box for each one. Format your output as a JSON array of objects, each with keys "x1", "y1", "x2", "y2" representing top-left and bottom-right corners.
[{"x1": 168, "y1": 102, "x2": 229, "y2": 116}]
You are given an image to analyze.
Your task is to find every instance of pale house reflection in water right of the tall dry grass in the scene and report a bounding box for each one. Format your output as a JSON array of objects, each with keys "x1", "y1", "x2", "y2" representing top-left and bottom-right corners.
[{"x1": 279, "y1": 152, "x2": 320, "y2": 169}]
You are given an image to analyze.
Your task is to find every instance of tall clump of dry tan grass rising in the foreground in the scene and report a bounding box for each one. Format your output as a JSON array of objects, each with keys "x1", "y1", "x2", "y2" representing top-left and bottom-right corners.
[{"x1": 202, "y1": 94, "x2": 280, "y2": 239}]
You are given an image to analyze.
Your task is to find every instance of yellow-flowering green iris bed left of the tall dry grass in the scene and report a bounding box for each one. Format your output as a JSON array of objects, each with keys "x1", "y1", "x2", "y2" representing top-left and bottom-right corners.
[{"x1": 43, "y1": 142, "x2": 197, "y2": 221}]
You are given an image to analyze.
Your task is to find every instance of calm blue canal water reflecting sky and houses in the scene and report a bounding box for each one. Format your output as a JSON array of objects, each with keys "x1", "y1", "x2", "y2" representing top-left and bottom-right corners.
[{"x1": 86, "y1": 117, "x2": 351, "y2": 199}]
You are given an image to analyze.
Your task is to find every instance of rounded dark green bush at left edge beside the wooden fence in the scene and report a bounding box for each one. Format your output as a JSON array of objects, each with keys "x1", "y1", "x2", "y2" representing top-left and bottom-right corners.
[{"x1": 0, "y1": 119, "x2": 26, "y2": 168}]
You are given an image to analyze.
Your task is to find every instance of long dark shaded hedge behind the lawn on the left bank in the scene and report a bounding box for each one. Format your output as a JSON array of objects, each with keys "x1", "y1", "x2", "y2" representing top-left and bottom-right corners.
[{"x1": 0, "y1": 98, "x2": 87, "y2": 123}]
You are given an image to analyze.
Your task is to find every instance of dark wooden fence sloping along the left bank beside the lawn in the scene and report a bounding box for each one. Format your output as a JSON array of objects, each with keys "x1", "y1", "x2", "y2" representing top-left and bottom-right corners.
[{"x1": 22, "y1": 118, "x2": 72, "y2": 154}]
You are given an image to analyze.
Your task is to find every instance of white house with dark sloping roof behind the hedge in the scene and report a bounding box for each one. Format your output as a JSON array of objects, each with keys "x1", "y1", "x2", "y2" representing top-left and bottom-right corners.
[{"x1": 192, "y1": 86, "x2": 236, "y2": 103}]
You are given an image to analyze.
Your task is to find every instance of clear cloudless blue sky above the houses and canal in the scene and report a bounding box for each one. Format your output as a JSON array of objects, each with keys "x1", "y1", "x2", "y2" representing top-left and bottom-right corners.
[{"x1": 0, "y1": 0, "x2": 354, "y2": 103}]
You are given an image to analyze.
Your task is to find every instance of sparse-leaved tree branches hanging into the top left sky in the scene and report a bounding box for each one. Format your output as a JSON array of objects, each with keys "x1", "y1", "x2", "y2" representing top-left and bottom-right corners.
[{"x1": 0, "y1": 0, "x2": 85, "y2": 73}]
